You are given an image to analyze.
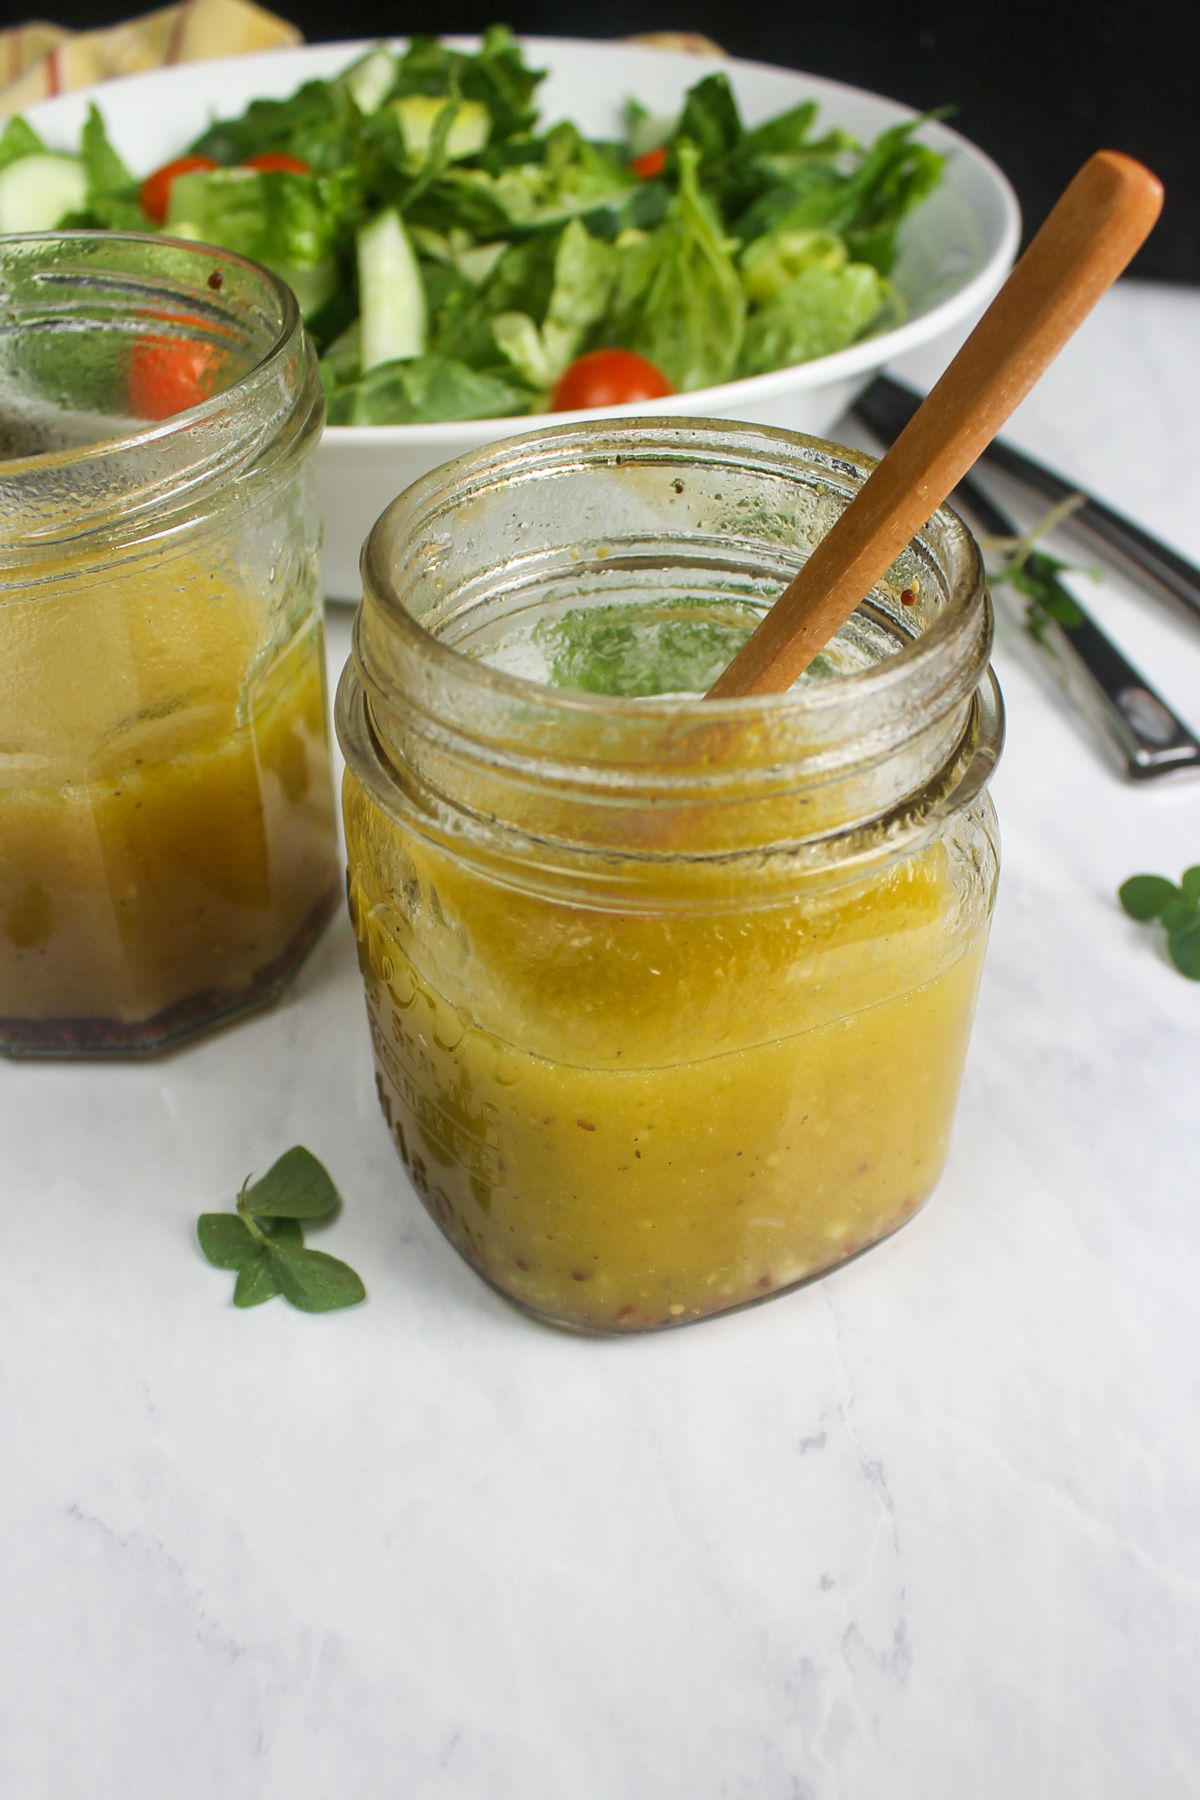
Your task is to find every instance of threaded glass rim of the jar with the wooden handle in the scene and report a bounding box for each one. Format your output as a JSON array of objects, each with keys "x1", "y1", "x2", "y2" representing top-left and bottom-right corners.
[{"x1": 349, "y1": 419, "x2": 999, "y2": 857}]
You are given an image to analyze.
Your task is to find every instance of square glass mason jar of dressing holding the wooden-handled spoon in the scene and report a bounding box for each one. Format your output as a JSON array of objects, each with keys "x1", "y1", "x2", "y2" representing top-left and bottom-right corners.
[{"x1": 336, "y1": 419, "x2": 1002, "y2": 1332}]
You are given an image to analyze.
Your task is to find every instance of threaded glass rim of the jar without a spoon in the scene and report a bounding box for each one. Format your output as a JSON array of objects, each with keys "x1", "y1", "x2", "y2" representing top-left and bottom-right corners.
[{"x1": 0, "y1": 230, "x2": 306, "y2": 553}]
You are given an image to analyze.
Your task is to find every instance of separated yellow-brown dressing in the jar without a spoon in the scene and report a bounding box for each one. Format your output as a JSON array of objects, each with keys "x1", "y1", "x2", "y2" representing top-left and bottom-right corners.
[{"x1": 0, "y1": 560, "x2": 338, "y2": 1049}]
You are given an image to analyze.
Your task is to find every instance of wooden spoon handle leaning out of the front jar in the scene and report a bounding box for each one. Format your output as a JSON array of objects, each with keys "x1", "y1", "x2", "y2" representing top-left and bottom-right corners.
[{"x1": 705, "y1": 149, "x2": 1162, "y2": 700}]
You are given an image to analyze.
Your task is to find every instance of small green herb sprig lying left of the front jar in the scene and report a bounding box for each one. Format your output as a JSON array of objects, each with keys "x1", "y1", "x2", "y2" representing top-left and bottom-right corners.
[{"x1": 196, "y1": 1143, "x2": 367, "y2": 1312}]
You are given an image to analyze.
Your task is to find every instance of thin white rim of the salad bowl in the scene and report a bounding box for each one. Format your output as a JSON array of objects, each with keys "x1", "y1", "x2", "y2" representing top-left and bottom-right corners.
[{"x1": 27, "y1": 32, "x2": 1022, "y2": 455}]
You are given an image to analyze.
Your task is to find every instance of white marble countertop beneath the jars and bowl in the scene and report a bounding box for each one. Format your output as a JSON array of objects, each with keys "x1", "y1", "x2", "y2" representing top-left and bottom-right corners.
[{"x1": 0, "y1": 273, "x2": 1200, "y2": 1800}]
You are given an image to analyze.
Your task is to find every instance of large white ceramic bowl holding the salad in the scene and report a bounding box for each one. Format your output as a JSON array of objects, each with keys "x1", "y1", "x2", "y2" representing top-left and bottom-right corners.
[{"x1": 29, "y1": 38, "x2": 1020, "y2": 599}]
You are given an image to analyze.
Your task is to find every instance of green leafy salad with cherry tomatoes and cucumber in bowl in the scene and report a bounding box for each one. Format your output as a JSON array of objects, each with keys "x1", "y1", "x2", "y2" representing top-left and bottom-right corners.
[{"x1": 0, "y1": 25, "x2": 943, "y2": 425}]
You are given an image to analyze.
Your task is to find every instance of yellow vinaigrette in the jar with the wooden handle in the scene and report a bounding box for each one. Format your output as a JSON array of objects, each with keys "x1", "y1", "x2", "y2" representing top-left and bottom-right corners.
[{"x1": 344, "y1": 776, "x2": 986, "y2": 1330}]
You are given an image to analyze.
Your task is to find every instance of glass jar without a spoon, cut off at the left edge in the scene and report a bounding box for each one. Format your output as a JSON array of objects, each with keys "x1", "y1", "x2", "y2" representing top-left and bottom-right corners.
[{"x1": 0, "y1": 232, "x2": 338, "y2": 1055}]
